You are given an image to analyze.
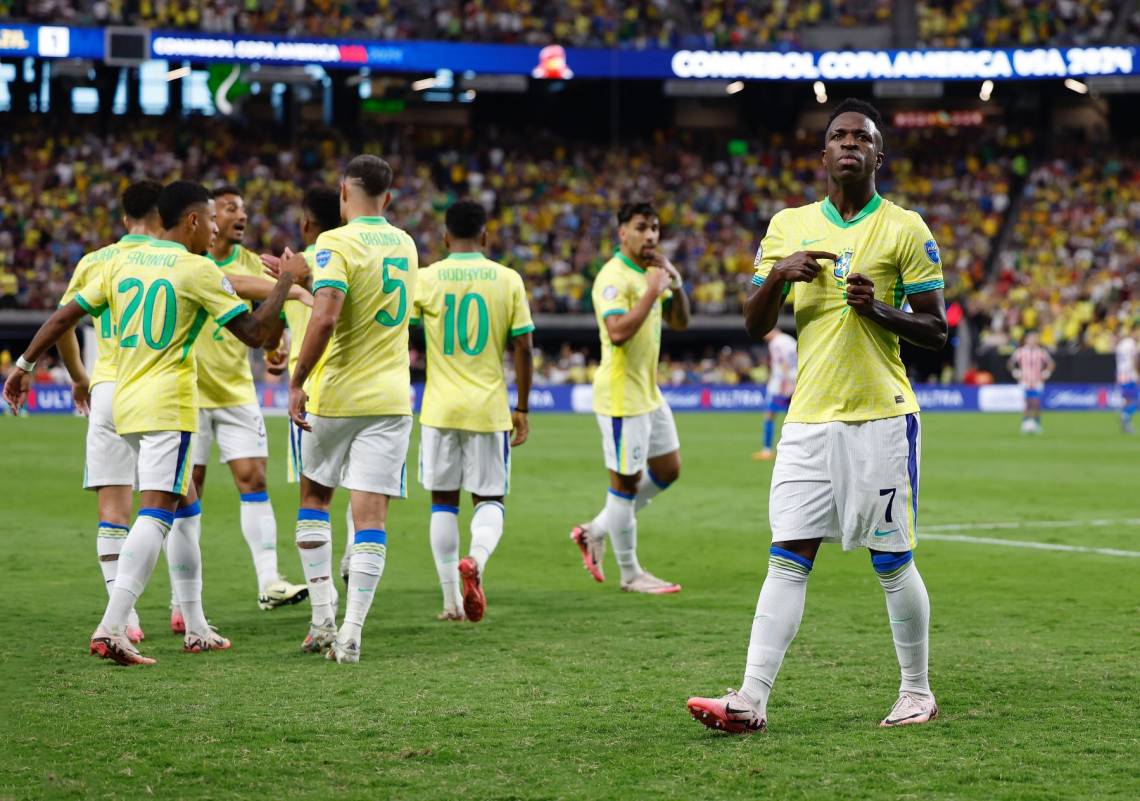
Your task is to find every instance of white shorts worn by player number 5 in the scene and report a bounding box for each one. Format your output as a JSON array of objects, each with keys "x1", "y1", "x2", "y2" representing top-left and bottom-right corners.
[{"x1": 299, "y1": 415, "x2": 412, "y2": 498}]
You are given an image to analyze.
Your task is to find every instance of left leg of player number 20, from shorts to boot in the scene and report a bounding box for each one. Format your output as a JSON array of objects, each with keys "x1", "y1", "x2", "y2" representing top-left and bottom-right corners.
[{"x1": 91, "y1": 432, "x2": 192, "y2": 664}]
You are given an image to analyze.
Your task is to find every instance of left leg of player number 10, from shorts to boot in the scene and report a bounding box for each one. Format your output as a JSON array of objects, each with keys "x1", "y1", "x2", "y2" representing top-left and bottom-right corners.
[{"x1": 418, "y1": 425, "x2": 464, "y2": 621}]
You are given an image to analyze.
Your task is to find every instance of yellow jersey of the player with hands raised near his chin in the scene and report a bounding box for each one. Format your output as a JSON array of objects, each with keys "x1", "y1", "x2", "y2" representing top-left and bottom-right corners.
[{"x1": 592, "y1": 251, "x2": 673, "y2": 417}]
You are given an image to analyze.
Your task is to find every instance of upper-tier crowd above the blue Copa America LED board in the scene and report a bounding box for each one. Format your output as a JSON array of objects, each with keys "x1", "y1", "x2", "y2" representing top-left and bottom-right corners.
[{"x1": 0, "y1": 0, "x2": 1124, "y2": 49}]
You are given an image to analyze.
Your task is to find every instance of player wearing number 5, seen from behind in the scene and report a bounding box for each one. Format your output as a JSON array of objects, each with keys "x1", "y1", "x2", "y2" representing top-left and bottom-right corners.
[{"x1": 283, "y1": 156, "x2": 420, "y2": 663}]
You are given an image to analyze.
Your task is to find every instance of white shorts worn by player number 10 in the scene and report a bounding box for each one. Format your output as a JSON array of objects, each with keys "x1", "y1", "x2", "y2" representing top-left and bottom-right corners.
[{"x1": 420, "y1": 425, "x2": 511, "y2": 498}]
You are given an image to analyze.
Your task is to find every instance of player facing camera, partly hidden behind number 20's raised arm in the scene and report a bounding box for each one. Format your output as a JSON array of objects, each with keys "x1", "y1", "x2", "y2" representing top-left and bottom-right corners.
[{"x1": 171, "y1": 186, "x2": 308, "y2": 619}]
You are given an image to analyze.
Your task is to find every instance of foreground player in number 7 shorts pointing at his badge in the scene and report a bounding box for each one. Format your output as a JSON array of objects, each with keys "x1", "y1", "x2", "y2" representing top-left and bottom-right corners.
[{"x1": 689, "y1": 100, "x2": 946, "y2": 734}]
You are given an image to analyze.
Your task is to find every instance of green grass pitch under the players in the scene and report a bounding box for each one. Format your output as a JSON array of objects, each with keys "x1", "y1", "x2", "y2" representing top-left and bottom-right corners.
[{"x1": 0, "y1": 414, "x2": 1140, "y2": 801}]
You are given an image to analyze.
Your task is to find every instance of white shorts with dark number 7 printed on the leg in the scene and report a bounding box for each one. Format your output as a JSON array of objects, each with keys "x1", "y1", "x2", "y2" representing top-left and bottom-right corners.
[{"x1": 768, "y1": 415, "x2": 921, "y2": 553}]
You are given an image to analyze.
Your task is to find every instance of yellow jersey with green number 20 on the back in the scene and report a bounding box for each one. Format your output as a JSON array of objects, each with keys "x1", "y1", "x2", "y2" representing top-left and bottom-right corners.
[{"x1": 75, "y1": 239, "x2": 249, "y2": 434}]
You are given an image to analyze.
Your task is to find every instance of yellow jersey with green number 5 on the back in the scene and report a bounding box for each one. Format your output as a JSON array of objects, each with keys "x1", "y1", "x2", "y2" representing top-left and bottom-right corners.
[{"x1": 306, "y1": 216, "x2": 420, "y2": 417}]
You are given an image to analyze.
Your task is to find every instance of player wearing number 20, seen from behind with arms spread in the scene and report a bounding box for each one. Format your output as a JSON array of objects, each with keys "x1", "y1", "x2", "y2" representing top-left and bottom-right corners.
[{"x1": 5, "y1": 181, "x2": 293, "y2": 665}]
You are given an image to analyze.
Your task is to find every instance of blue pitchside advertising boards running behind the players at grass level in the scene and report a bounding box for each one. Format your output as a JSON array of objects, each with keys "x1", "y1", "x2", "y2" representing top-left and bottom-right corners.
[{"x1": 15, "y1": 384, "x2": 1122, "y2": 415}]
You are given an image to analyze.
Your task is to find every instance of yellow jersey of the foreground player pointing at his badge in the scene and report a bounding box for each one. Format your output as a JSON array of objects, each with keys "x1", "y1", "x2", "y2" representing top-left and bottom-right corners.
[{"x1": 752, "y1": 195, "x2": 944, "y2": 423}]
